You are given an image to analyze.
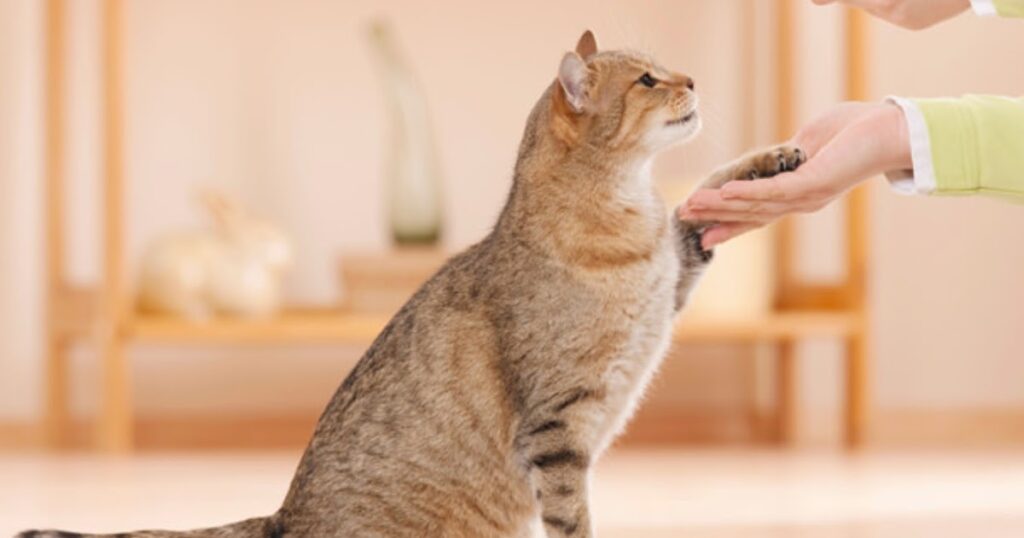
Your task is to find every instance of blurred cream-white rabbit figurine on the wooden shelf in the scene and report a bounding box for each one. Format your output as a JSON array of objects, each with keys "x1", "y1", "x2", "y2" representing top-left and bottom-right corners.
[{"x1": 139, "y1": 194, "x2": 292, "y2": 320}]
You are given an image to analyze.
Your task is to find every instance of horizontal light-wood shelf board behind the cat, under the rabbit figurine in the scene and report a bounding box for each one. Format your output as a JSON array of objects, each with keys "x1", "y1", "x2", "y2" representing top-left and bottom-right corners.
[{"x1": 128, "y1": 309, "x2": 858, "y2": 344}]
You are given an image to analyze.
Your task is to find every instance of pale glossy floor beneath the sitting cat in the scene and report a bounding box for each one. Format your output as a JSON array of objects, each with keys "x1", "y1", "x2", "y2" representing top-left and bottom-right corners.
[{"x1": 6, "y1": 450, "x2": 1024, "y2": 538}]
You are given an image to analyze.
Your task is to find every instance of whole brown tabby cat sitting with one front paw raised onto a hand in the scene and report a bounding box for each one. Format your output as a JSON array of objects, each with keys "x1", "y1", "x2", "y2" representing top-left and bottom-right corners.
[{"x1": 22, "y1": 32, "x2": 804, "y2": 538}]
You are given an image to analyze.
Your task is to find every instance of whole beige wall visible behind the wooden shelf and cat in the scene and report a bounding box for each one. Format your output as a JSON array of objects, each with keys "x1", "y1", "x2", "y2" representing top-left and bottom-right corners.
[{"x1": 0, "y1": 0, "x2": 1024, "y2": 430}]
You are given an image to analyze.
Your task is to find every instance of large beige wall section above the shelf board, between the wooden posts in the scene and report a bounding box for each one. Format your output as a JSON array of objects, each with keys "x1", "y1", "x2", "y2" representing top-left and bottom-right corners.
[{"x1": 119, "y1": 0, "x2": 757, "y2": 301}]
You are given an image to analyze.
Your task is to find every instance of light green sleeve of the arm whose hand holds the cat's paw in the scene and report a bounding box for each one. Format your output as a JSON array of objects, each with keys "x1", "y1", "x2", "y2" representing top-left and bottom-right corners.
[{"x1": 913, "y1": 95, "x2": 1024, "y2": 200}]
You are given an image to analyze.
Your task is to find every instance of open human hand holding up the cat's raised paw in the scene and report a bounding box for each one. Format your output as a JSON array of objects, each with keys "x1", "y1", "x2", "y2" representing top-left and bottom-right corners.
[{"x1": 679, "y1": 102, "x2": 912, "y2": 249}]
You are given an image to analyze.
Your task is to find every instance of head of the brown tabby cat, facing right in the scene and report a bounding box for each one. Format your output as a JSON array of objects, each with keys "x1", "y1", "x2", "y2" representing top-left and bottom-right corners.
[{"x1": 550, "y1": 31, "x2": 700, "y2": 158}]
